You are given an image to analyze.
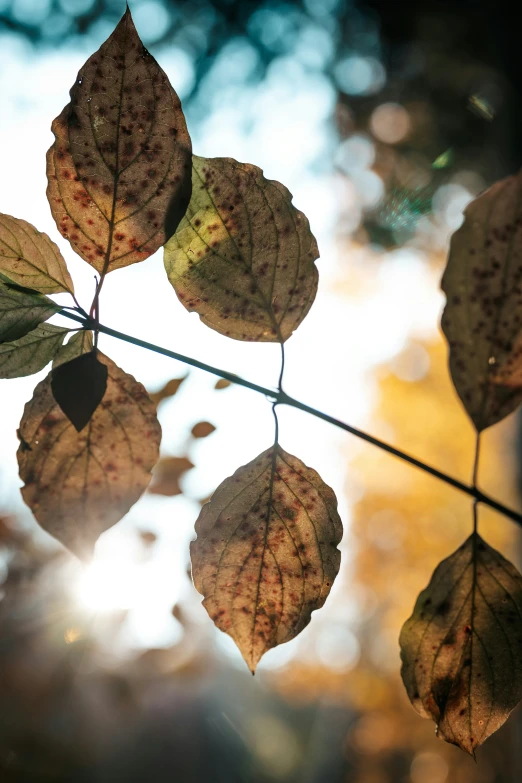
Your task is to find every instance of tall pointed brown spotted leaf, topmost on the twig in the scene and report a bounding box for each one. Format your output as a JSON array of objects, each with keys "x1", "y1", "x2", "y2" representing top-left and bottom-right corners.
[{"x1": 47, "y1": 9, "x2": 191, "y2": 273}]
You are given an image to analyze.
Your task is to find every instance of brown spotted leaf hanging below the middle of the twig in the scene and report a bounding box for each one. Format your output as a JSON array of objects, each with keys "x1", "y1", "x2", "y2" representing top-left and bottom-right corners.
[{"x1": 190, "y1": 446, "x2": 342, "y2": 672}]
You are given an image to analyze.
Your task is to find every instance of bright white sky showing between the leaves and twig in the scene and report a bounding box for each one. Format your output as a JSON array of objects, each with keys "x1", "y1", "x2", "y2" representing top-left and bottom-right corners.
[{"x1": 0, "y1": 19, "x2": 446, "y2": 666}]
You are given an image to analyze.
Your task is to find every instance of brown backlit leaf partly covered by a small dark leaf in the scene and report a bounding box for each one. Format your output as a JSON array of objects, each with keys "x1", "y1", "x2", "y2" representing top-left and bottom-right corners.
[{"x1": 17, "y1": 353, "x2": 161, "y2": 557}]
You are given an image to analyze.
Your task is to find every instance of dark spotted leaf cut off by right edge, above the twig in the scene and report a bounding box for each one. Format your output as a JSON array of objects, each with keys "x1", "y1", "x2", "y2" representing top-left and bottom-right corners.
[{"x1": 442, "y1": 174, "x2": 522, "y2": 432}]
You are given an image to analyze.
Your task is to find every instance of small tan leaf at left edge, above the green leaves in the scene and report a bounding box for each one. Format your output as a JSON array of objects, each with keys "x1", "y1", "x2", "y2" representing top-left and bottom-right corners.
[{"x1": 0, "y1": 214, "x2": 74, "y2": 294}]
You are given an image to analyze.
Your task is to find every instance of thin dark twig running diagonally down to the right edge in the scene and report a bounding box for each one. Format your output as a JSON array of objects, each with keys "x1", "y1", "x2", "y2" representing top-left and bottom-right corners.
[{"x1": 61, "y1": 310, "x2": 522, "y2": 527}]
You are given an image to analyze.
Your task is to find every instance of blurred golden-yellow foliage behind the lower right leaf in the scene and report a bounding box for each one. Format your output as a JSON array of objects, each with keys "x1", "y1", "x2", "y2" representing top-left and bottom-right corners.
[{"x1": 277, "y1": 328, "x2": 520, "y2": 783}]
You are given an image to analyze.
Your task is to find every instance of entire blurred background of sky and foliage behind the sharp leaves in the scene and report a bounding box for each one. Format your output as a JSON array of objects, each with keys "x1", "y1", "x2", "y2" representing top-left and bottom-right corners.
[{"x1": 0, "y1": 0, "x2": 522, "y2": 783}]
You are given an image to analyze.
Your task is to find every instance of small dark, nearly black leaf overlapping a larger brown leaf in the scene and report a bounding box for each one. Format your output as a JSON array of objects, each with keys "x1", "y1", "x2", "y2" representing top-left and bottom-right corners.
[{"x1": 51, "y1": 349, "x2": 108, "y2": 432}]
